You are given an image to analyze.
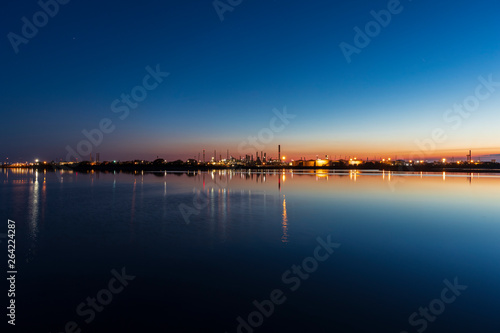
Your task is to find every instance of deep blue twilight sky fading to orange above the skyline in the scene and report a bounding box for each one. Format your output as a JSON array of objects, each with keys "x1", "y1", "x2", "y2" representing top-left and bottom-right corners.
[{"x1": 0, "y1": 0, "x2": 500, "y2": 162}]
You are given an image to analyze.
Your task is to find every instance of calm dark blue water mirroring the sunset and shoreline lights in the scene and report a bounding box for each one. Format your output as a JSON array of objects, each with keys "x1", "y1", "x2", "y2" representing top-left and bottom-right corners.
[{"x1": 0, "y1": 170, "x2": 500, "y2": 333}]
